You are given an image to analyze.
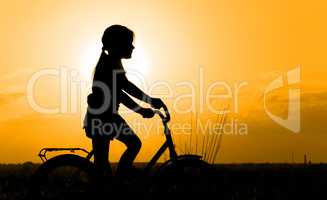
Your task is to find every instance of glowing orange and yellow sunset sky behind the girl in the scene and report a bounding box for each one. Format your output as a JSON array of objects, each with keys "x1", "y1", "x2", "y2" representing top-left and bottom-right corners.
[{"x1": 0, "y1": 0, "x2": 327, "y2": 163}]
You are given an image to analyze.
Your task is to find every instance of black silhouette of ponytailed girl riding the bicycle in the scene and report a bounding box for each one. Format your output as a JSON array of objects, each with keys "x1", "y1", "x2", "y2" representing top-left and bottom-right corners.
[{"x1": 84, "y1": 25, "x2": 164, "y2": 175}]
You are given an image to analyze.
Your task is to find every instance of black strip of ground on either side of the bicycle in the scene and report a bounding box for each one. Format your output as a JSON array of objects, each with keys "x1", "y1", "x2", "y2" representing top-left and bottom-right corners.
[{"x1": 0, "y1": 163, "x2": 327, "y2": 200}]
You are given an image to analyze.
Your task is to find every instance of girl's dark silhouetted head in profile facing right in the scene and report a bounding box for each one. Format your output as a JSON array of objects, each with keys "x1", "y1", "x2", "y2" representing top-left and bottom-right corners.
[{"x1": 102, "y1": 25, "x2": 134, "y2": 58}]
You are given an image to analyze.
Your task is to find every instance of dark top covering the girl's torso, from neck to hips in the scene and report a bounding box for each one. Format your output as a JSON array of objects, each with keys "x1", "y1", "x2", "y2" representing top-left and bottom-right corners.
[{"x1": 83, "y1": 53, "x2": 127, "y2": 138}]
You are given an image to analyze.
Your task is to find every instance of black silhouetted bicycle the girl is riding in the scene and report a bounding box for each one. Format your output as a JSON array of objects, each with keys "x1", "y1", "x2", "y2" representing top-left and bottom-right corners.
[{"x1": 31, "y1": 106, "x2": 211, "y2": 199}]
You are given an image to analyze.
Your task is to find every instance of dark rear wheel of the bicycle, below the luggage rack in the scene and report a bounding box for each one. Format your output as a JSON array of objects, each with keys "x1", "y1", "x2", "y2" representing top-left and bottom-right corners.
[{"x1": 29, "y1": 154, "x2": 96, "y2": 200}]
